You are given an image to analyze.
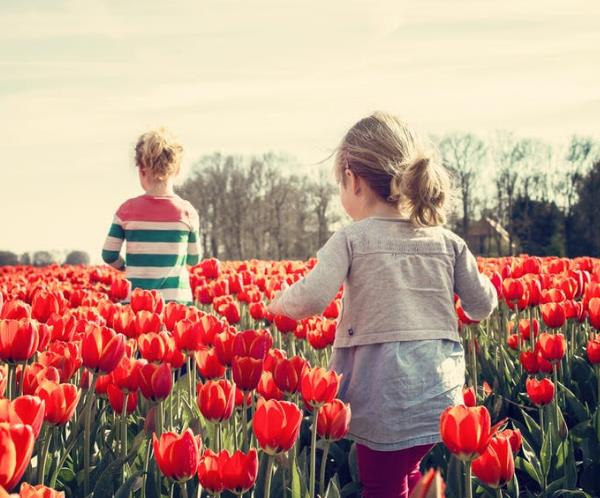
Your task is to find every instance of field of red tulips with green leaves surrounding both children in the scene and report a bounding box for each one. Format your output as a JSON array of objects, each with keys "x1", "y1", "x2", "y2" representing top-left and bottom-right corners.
[{"x1": 0, "y1": 255, "x2": 600, "y2": 498}]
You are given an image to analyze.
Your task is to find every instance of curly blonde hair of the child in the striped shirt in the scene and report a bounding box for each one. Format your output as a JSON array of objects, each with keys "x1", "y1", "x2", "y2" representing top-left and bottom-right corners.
[{"x1": 135, "y1": 128, "x2": 183, "y2": 182}]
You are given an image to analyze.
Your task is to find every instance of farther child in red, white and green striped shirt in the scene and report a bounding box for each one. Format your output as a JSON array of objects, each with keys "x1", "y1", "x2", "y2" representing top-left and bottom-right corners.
[{"x1": 102, "y1": 129, "x2": 199, "y2": 304}]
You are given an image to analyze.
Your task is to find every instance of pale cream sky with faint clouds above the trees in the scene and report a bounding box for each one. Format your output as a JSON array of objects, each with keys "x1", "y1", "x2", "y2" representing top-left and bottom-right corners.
[{"x1": 0, "y1": 0, "x2": 600, "y2": 260}]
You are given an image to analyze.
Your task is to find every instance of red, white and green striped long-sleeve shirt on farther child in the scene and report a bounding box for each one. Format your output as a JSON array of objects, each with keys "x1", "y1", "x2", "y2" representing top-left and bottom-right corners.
[{"x1": 102, "y1": 195, "x2": 199, "y2": 303}]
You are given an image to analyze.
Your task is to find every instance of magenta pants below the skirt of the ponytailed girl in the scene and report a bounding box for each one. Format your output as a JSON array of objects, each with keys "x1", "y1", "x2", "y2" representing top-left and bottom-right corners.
[{"x1": 356, "y1": 444, "x2": 433, "y2": 498}]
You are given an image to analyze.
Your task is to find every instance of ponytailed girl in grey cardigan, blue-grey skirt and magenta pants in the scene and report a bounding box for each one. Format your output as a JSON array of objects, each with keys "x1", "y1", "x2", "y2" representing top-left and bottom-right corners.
[{"x1": 270, "y1": 112, "x2": 497, "y2": 498}]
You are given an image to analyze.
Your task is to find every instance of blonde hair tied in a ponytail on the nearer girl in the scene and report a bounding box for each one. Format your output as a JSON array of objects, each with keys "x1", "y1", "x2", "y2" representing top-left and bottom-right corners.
[{"x1": 335, "y1": 112, "x2": 452, "y2": 226}]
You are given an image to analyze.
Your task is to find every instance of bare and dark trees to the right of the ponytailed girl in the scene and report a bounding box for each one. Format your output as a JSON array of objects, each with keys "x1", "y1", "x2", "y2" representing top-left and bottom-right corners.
[{"x1": 437, "y1": 132, "x2": 600, "y2": 257}]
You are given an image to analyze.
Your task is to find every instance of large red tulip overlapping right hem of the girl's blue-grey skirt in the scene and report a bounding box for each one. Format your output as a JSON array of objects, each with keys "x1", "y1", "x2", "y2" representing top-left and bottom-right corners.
[{"x1": 440, "y1": 405, "x2": 492, "y2": 460}]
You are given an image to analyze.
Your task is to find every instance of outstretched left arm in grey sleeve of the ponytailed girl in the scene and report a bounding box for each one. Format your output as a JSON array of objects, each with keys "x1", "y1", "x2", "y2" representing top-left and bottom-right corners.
[{"x1": 269, "y1": 230, "x2": 352, "y2": 320}]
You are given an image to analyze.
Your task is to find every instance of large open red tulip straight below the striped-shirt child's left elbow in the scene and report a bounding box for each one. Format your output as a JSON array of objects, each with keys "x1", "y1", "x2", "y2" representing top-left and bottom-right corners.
[{"x1": 81, "y1": 325, "x2": 125, "y2": 373}]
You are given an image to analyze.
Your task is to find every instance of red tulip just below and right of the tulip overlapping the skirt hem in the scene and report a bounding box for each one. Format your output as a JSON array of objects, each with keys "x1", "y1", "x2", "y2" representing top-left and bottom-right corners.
[{"x1": 473, "y1": 437, "x2": 515, "y2": 488}]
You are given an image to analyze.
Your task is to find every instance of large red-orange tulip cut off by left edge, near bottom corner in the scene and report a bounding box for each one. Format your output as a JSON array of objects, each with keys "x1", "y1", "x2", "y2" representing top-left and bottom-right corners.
[{"x1": 0, "y1": 422, "x2": 35, "y2": 490}]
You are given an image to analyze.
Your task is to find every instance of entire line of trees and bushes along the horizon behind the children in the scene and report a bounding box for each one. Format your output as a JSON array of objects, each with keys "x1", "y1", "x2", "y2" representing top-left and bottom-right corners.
[{"x1": 0, "y1": 132, "x2": 600, "y2": 266}]
